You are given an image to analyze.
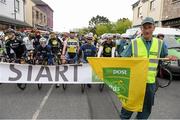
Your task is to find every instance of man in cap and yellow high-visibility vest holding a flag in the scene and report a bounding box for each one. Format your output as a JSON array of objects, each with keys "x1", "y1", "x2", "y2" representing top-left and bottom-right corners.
[{"x1": 120, "y1": 17, "x2": 176, "y2": 119}]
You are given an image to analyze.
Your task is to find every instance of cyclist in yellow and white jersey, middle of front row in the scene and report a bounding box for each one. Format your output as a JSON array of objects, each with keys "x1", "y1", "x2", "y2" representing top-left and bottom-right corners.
[{"x1": 62, "y1": 31, "x2": 79, "y2": 63}]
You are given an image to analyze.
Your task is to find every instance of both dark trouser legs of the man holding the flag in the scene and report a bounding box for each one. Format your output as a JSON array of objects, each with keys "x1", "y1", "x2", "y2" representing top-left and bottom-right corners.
[{"x1": 120, "y1": 84, "x2": 155, "y2": 119}]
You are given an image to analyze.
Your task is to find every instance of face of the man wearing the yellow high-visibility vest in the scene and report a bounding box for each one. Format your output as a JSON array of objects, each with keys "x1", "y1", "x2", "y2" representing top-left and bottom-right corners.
[{"x1": 141, "y1": 23, "x2": 155, "y2": 39}]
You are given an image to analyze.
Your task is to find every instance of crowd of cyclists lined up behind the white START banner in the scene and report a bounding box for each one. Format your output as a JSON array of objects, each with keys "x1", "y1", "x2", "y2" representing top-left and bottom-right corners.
[{"x1": 0, "y1": 29, "x2": 129, "y2": 91}]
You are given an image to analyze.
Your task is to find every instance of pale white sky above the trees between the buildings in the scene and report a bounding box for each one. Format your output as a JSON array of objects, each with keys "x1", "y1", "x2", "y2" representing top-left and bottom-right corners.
[{"x1": 43, "y1": 0, "x2": 137, "y2": 32}]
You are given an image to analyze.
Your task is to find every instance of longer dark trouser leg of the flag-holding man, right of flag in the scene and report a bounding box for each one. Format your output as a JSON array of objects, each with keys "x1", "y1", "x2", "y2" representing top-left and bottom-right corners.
[{"x1": 136, "y1": 84, "x2": 155, "y2": 119}]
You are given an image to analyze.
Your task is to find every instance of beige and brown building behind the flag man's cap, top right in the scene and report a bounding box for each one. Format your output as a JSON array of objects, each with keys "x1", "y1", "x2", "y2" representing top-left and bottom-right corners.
[{"x1": 132, "y1": 0, "x2": 180, "y2": 28}]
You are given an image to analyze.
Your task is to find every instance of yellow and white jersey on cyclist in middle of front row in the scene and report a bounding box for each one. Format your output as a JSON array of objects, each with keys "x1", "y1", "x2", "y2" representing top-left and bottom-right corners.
[{"x1": 67, "y1": 38, "x2": 79, "y2": 53}]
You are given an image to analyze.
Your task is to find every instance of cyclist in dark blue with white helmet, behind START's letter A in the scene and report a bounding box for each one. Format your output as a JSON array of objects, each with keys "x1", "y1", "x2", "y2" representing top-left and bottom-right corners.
[{"x1": 35, "y1": 38, "x2": 53, "y2": 65}]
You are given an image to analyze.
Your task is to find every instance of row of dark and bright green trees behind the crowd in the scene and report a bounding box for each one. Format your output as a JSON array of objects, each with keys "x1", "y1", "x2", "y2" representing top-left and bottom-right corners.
[{"x1": 75, "y1": 15, "x2": 132, "y2": 36}]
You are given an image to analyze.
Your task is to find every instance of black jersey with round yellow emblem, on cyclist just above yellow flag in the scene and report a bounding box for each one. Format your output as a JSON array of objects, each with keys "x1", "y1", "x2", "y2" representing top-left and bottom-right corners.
[{"x1": 101, "y1": 41, "x2": 115, "y2": 57}]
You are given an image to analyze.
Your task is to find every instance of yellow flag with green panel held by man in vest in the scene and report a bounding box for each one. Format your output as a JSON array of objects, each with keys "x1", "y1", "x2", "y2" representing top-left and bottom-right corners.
[{"x1": 88, "y1": 58, "x2": 149, "y2": 112}]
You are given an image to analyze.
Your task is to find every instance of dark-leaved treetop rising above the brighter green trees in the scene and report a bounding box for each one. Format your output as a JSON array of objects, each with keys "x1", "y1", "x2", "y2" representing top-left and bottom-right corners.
[{"x1": 89, "y1": 15, "x2": 110, "y2": 28}]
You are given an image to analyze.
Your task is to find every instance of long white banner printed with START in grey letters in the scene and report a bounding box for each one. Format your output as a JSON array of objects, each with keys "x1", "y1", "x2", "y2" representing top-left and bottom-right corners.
[{"x1": 0, "y1": 63, "x2": 102, "y2": 84}]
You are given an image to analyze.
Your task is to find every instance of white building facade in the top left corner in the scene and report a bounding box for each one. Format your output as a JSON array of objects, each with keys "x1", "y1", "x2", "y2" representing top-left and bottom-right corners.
[{"x1": 0, "y1": 0, "x2": 29, "y2": 29}]
